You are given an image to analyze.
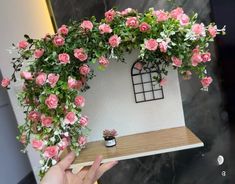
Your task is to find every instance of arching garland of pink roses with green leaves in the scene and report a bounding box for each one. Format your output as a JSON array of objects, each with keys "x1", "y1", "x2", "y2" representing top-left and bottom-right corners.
[{"x1": 1, "y1": 7, "x2": 225, "y2": 176}]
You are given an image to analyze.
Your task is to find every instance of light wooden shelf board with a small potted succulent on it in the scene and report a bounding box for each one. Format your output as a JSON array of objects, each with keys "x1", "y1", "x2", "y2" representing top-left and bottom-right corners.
[{"x1": 73, "y1": 127, "x2": 204, "y2": 167}]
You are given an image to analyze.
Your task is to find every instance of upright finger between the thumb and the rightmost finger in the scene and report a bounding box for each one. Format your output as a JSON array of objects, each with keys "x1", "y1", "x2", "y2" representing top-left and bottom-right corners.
[{"x1": 84, "y1": 156, "x2": 103, "y2": 184}]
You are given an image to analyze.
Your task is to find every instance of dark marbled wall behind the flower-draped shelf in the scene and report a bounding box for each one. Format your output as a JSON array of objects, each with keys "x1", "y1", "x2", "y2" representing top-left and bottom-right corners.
[{"x1": 48, "y1": 0, "x2": 235, "y2": 184}]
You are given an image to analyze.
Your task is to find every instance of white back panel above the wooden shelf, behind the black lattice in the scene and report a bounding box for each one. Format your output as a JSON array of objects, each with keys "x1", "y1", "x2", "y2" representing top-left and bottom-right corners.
[{"x1": 83, "y1": 52, "x2": 185, "y2": 141}]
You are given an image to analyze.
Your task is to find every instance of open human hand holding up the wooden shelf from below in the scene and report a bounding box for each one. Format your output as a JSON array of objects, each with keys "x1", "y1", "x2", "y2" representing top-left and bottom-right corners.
[{"x1": 41, "y1": 152, "x2": 118, "y2": 184}]
